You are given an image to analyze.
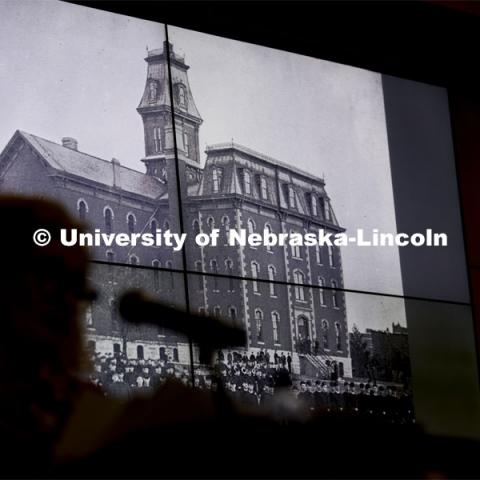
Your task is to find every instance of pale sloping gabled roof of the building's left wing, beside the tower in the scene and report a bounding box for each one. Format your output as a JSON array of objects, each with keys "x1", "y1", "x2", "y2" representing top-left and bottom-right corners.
[{"x1": 8, "y1": 131, "x2": 166, "y2": 199}]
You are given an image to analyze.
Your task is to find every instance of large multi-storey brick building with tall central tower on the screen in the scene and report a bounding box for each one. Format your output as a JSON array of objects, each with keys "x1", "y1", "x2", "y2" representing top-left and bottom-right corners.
[{"x1": 0, "y1": 44, "x2": 351, "y2": 376}]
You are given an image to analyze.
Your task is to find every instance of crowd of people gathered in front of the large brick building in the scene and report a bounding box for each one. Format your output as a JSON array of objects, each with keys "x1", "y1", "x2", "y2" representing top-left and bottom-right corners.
[{"x1": 90, "y1": 351, "x2": 414, "y2": 423}]
